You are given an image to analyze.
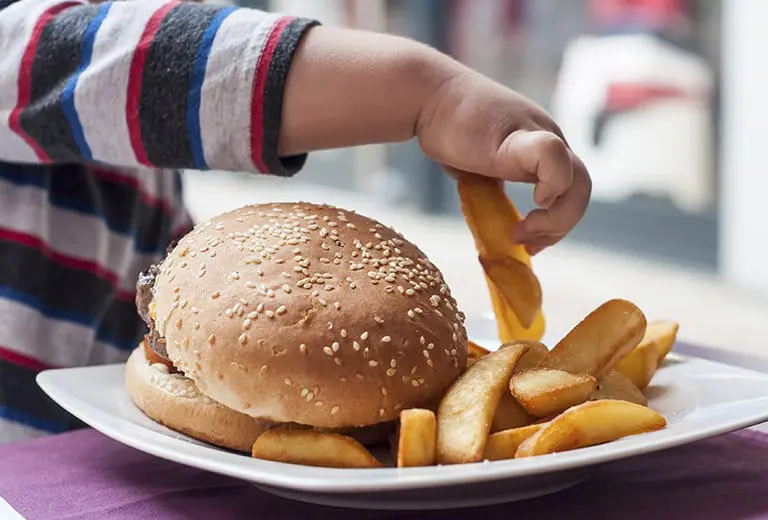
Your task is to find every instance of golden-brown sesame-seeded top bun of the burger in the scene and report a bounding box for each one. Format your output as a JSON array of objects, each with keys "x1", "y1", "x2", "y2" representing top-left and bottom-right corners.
[{"x1": 155, "y1": 203, "x2": 467, "y2": 428}]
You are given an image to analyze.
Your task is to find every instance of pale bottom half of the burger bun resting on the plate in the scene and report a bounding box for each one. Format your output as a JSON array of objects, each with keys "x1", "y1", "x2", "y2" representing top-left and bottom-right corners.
[{"x1": 125, "y1": 345, "x2": 394, "y2": 453}]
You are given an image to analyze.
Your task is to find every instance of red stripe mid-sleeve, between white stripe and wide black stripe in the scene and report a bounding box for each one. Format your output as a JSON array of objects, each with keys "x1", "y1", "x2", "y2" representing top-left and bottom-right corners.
[{"x1": 125, "y1": 0, "x2": 180, "y2": 167}]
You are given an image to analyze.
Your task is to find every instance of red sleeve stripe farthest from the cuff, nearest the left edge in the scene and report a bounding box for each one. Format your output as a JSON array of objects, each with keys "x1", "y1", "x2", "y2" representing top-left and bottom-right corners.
[{"x1": 8, "y1": 2, "x2": 82, "y2": 163}]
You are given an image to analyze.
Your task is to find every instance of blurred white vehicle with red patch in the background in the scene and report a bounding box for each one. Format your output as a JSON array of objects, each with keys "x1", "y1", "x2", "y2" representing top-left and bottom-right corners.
[{"x1": 551, "y1": 34, "x2": 715, "y2": 212}]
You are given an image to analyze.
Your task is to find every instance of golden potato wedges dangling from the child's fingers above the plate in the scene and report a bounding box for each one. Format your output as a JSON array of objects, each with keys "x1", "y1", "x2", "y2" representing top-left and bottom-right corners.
[{"x1": 458, "y1": 174, "x2": 544, "y2": 343}]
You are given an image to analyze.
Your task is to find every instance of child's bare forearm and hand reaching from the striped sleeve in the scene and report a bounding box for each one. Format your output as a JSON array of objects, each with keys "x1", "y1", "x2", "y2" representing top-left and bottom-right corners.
[{"x1": 280, "y1": 27, "x2": 591, "y2": 253}]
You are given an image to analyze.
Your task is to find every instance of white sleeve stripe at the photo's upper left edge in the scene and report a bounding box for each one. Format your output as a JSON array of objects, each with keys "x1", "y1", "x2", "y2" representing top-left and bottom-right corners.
[{"x1": 0, "y1": 0, "x2": 78, "y2": 163}]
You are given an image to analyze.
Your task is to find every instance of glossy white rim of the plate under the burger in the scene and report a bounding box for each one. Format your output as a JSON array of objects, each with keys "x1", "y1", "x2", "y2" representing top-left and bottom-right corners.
[{"x1": 36, "y1": 355, "x2": 768, "y2": 494}]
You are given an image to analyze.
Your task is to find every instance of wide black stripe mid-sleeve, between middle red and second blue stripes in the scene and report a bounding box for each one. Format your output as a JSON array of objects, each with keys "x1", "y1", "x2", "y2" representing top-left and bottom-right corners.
[{"x1": 139, "y1": 4, "x2": 222, "y2": 168}]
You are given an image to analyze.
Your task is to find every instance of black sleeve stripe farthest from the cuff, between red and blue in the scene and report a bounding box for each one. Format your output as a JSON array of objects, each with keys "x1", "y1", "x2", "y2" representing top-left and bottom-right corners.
[{"x1": 19, "y1": 5, "x2": 98, "y2": 162}]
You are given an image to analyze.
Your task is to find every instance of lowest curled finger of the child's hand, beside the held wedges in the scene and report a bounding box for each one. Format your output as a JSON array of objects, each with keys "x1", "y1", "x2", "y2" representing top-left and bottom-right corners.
[{"x1": 514, "y1": 151, "x2": 592, "y2": 254}]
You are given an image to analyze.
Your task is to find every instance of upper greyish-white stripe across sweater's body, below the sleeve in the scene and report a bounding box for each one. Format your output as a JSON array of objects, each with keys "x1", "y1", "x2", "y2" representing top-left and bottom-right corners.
[{"x1": 0, "y1": 179, "x2": 158, "y2": 292}]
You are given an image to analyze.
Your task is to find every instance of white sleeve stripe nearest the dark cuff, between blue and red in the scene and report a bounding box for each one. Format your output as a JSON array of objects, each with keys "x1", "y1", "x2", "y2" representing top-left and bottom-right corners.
[{"x1": 200, "y1": 9, "x2": 280, "y2": 171}]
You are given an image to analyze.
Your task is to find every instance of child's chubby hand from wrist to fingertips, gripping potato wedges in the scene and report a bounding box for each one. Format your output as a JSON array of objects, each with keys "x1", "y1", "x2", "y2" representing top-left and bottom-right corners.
[{"x1": 416, "y1": 71, "x2": 592, "y2": 254}]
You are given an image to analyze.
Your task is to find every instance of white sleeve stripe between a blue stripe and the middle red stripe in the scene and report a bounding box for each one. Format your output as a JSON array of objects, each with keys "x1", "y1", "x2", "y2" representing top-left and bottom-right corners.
[{"x1": 75, "y1": 0, "x2": 167, "y2": 166}]
